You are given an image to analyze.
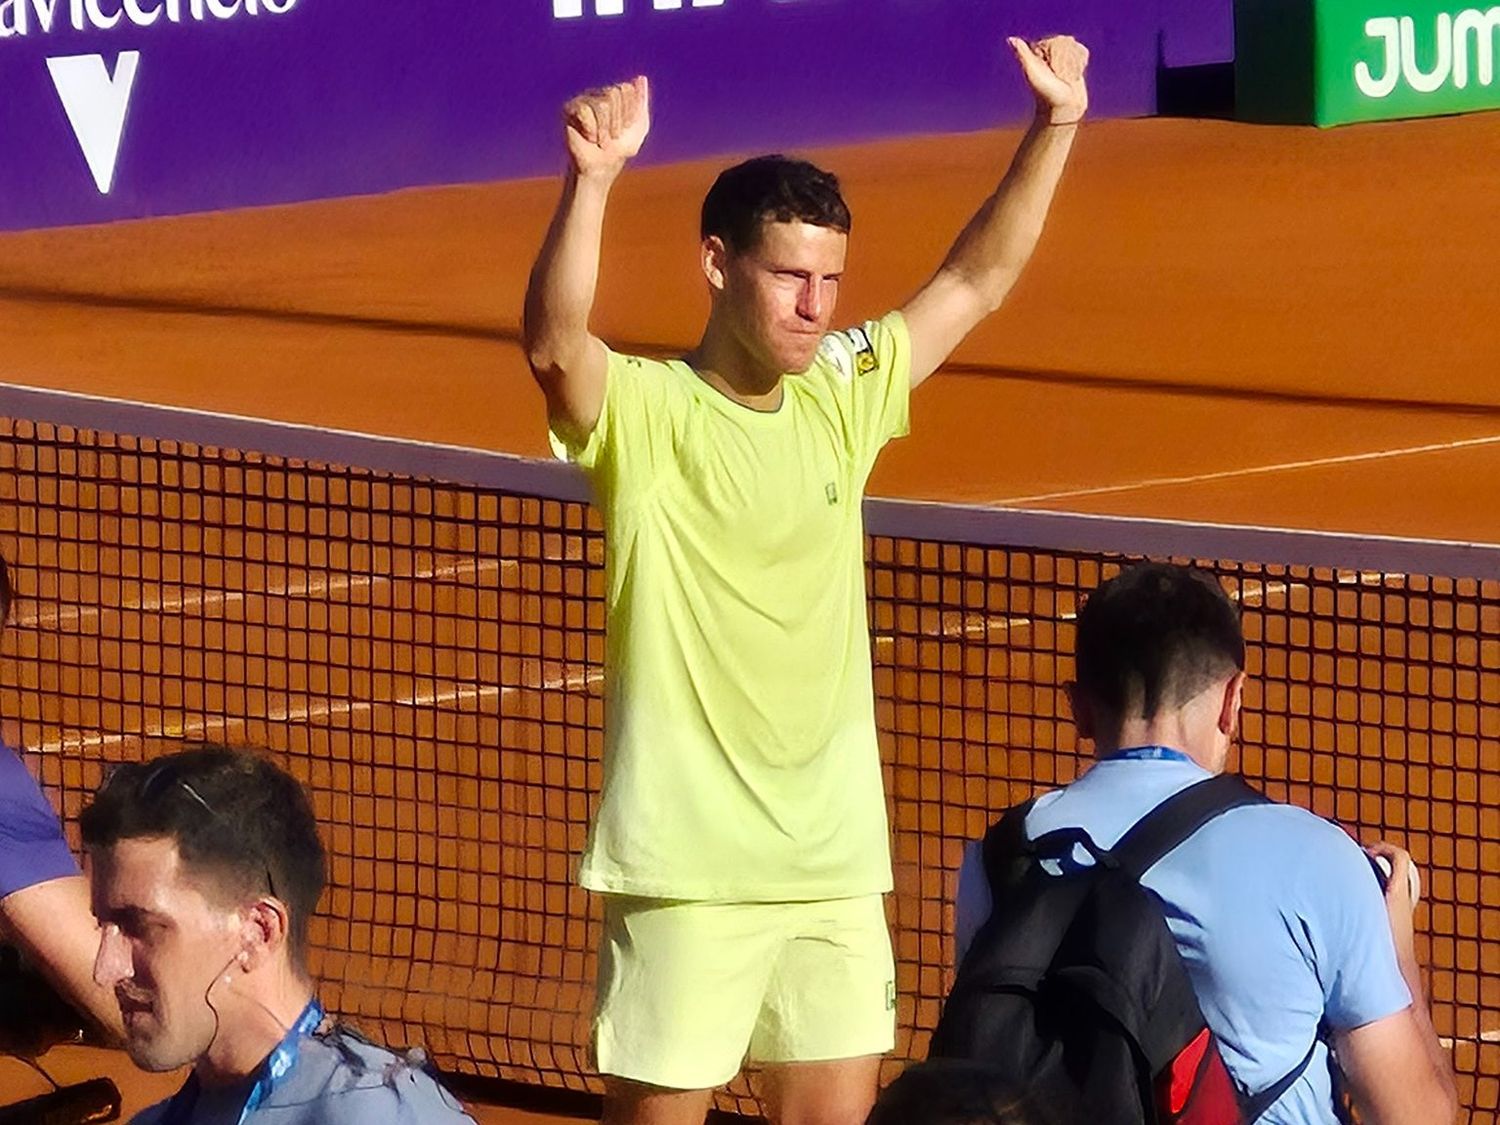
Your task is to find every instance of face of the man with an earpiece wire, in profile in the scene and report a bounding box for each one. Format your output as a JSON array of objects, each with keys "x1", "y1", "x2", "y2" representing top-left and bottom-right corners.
[{"x1": 93, "y1": 839, "x2": 243, "y2": 1071}]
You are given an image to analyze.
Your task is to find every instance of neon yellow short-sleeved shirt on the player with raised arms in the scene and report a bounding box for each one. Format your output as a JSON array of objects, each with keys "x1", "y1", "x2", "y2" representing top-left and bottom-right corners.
[{"x1": 554, "y1": 314, "x2": 911, "y2": 902}]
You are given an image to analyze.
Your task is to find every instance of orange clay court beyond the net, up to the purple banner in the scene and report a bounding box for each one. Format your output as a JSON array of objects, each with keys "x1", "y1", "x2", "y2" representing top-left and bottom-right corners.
[{"x1": 0, "y1": 114, "x2": 1500, "y2": 542}]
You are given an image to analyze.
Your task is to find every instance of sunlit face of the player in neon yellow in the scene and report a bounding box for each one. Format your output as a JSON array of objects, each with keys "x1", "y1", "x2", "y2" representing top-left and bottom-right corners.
[{"x1": 711, "y1": 222, "x2": 849, "y2": 375}]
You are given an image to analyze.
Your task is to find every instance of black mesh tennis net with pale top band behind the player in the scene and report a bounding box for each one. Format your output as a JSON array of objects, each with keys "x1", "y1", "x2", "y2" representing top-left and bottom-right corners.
[{"x1": 0, "y1": 387, "x2": 1500, "y2": 1122}]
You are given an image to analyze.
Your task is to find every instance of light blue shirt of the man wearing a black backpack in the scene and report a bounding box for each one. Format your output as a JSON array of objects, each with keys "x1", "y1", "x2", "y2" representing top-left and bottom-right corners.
[{"x1": 957, "y1": 755, "x2": 1412, "y2": 1125}]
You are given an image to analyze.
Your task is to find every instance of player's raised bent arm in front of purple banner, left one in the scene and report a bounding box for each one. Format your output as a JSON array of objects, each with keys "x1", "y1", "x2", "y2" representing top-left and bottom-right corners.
[{"x1": 521, "y1": 78, "x2": 651, "y2": 441}]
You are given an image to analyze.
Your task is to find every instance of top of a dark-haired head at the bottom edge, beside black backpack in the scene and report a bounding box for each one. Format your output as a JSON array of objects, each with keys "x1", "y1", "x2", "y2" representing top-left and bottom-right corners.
[{"x1": 866, "y1": 1059, "x2": 1082, "y2": 1125}]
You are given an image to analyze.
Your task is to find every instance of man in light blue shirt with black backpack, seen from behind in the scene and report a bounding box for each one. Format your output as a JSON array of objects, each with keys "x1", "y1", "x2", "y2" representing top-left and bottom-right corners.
[{"x1": 932, "y1": 563, "x2": 1458, "y2": 1125}]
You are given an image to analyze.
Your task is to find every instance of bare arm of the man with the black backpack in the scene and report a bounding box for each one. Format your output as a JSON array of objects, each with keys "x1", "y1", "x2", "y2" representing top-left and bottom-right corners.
[{"x1": 1334, "y1": 845, "x2": 1458, "y2": 1125}]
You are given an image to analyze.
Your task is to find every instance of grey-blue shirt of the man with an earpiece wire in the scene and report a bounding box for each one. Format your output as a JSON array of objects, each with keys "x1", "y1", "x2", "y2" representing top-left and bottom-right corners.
[{"x1": 131, "y1": 1032, "x2": 474, "y2": 1125}]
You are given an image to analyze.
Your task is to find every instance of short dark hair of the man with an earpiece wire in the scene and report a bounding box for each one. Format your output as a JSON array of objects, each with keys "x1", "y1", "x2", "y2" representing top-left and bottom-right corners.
[{"x1": 78, "y1": 746, "x2": 327, "y2": 968}]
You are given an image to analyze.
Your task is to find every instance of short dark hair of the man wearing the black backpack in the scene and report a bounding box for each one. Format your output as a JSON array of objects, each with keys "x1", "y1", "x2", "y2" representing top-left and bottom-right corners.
[{"x1": 1076, "y1": 563, "x2": 1245, "y2": 720}]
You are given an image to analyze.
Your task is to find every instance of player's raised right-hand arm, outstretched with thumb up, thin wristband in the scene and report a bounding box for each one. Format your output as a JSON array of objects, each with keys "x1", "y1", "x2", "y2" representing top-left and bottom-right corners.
[{"x1": 902, "y1": 36, "x2": 1089, "y2": 387}]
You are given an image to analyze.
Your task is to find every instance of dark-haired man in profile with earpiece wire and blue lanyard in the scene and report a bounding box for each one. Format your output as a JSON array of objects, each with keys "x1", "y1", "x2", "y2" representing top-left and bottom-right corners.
[{"x1": 80, "y1": 747, "x2": 473, "y2": 1125}]
